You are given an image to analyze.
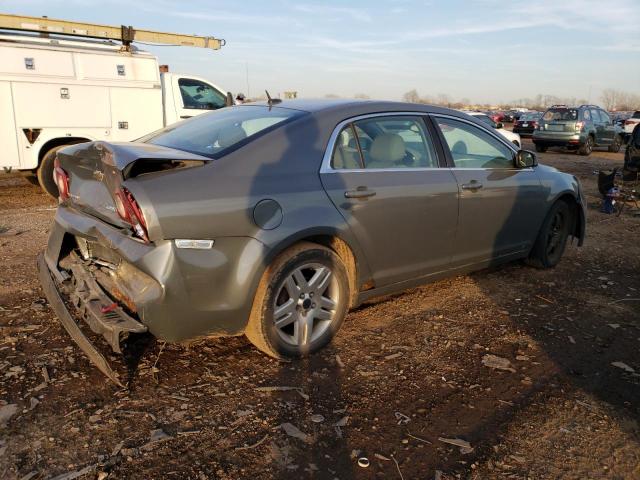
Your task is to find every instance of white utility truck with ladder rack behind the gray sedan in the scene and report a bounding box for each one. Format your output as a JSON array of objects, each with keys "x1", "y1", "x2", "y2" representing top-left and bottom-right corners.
[{"x1": 0, "y1": 14, "x2": 232, "y2": 197}]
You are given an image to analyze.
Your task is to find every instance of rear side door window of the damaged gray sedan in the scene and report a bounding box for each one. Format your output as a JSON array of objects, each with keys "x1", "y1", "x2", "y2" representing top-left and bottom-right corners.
[{"x1": 332, "y1": 115, "x2": 438, "y2": 169}]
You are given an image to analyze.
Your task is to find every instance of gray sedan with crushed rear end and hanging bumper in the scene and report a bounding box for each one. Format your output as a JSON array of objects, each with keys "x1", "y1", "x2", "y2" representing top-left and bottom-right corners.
[{"x1": 39, "y1": 100, "x2": 585, "y2": 378}]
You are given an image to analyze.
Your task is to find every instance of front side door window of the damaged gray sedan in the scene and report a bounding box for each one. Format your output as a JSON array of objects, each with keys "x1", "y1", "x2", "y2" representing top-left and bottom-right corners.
[{"x1": 436, "y1": 117, "x2": 514, "y2": 168}]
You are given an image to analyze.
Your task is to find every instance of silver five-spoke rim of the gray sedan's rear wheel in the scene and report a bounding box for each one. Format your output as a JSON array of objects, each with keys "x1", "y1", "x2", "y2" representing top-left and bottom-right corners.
[{"x1": 273, "y1": 263, "x2": 340, "y2": 348}]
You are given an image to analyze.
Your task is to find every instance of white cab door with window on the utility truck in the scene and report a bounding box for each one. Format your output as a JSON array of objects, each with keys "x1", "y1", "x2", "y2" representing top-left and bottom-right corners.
[{"x1": 167, "y1": 75, "x2": 226, "y2": 124}]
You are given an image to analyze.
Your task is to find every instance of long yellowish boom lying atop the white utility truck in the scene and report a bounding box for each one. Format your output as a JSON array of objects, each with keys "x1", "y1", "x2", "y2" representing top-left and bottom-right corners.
[{"x1": 0, "y1": 13, "x2": 226, "y2": 50}]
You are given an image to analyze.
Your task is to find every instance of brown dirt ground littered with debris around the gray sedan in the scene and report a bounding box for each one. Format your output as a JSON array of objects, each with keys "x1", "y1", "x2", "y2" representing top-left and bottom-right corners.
[{"x1": 0, "y1": 140, "x2": 640, "y2": 480}]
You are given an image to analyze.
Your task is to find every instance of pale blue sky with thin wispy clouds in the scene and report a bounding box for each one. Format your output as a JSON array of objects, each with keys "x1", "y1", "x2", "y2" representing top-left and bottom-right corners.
[{"x1": 0, "y1": 0, "x2": 640, "y2": 102}]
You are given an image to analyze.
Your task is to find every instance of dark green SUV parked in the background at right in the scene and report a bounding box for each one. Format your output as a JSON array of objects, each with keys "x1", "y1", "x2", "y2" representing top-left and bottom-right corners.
[{"x1": 533, "y1": 105, "x2": 623, "y2": 155}]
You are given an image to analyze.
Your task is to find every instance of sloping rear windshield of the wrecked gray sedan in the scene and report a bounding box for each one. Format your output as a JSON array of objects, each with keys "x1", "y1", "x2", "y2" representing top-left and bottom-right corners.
[{"x1": 139, "y1": 105, "x2": 305, "y2": 159}]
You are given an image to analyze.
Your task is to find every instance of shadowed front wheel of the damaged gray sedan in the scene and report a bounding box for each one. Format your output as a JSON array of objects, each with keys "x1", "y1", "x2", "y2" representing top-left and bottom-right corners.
[{"x1": 526, "y1": 200, "x2": 574, "y2": 268}]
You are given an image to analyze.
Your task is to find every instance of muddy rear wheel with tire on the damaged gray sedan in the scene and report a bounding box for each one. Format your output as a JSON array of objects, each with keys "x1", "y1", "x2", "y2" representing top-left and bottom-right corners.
[{"x1": 245, "y1": 242, "x2": 350, "y2": 359}]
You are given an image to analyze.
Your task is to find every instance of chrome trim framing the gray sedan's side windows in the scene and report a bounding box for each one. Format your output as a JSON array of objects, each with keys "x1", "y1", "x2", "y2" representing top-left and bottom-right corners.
[{"x1": 320, "y1": 111, "x2": 533, "y2": 173}]
